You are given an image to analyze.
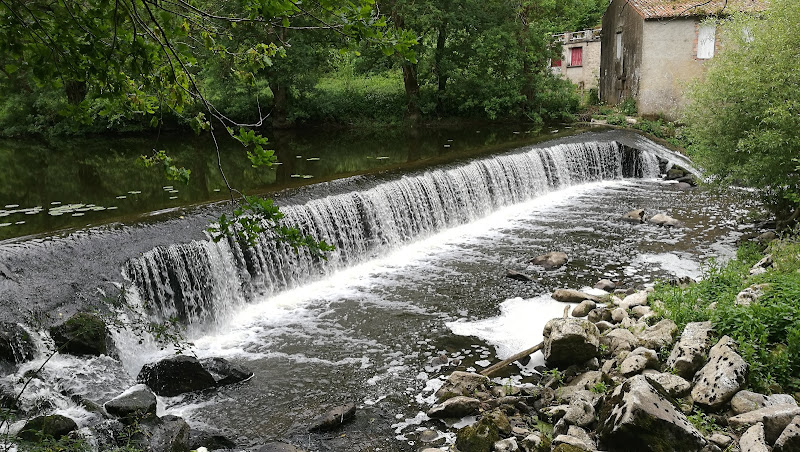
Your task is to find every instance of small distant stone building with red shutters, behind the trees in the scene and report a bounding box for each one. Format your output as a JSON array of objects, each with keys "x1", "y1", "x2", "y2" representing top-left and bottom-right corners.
[{"x1": 550, "y1": 28, "x2": 600, "y2": 90}]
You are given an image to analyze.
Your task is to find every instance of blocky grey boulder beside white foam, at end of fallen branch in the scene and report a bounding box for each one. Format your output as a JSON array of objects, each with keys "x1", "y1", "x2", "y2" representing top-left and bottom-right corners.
[{"x1": 543, "y1": 318, "x2": 600, "y2": 366}]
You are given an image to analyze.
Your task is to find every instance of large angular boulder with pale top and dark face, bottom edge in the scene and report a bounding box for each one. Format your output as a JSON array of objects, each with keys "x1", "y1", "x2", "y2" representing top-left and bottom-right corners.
[{"x1": 597, "y1": 375, "x2": 706, "y2": 452}]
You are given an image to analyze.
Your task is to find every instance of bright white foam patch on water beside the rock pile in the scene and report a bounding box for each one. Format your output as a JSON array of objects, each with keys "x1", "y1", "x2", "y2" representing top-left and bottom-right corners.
[{"x1": 447, "y1": 295, "x2": 566, "y2": 367}]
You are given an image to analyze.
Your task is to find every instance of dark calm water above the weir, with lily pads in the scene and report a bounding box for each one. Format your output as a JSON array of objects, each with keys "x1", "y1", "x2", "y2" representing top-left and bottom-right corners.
[{"x1": 0, "y1": 124, "x2": 574, "y2": 241}]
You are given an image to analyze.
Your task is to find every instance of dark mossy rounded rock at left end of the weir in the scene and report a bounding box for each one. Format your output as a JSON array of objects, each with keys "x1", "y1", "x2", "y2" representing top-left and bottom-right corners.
[{"x1": 50, "y1": 312, "x2": 114, "y2": 356}]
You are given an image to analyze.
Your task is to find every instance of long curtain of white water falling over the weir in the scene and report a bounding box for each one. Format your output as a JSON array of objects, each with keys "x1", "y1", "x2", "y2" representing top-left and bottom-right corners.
[{"x1": 124, "y1": 141, "x2": 660, "y2": 325}]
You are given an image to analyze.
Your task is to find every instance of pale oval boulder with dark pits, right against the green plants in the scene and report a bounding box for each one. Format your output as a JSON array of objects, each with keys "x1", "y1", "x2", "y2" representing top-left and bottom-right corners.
[{"x1": 692, "y1": 336, "x2": 747, "y2": 410}]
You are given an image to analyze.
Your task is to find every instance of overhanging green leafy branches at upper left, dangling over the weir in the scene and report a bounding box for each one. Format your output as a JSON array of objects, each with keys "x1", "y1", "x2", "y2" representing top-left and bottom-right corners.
[{"x1": 0, "y1": 0, "x2": 415, "y2": 247}]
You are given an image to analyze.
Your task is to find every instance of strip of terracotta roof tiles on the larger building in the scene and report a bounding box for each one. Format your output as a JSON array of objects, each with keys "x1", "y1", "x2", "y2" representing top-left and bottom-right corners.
[{"x1": 628, "y1": 0, "x2": 767, "y2": 19}]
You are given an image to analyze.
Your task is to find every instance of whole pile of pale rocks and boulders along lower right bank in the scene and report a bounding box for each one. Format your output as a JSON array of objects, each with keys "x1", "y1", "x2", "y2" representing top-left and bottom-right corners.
[{"x1": 423, "y1": 281, "x2": 800, "y2": 452}]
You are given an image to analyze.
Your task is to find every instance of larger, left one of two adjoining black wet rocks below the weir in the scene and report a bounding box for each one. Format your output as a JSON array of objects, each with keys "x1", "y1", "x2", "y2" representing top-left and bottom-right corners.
[{"x1": 136, "y1": 355, "x2": 216, "y2": 397}]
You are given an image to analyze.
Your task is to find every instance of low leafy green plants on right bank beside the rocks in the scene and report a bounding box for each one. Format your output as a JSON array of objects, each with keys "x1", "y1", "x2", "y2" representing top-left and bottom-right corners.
[{"x1": 650, "y1": 236, "x2": 800, "y2": 393}]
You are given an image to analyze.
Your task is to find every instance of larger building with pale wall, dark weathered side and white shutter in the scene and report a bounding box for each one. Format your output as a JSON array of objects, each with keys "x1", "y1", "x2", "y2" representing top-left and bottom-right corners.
[{"x1": 600, "y1": 0, "x2": 767, "y2": 119}]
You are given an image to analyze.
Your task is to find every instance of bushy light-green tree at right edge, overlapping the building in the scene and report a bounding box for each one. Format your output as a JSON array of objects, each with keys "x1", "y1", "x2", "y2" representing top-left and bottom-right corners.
[{"x1": 684, "y1": 0, "x2": 800, "y2": 226}]
